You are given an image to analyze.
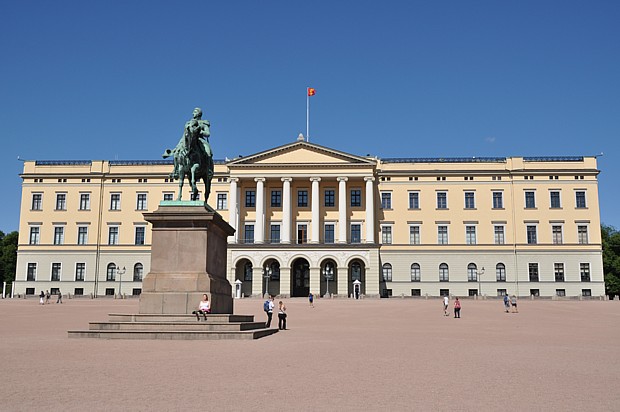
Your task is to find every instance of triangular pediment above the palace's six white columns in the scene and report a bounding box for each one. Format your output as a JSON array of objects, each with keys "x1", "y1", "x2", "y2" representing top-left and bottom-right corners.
[{"x1": 228, "y1": 141, "x2": 375, "y2": 168}]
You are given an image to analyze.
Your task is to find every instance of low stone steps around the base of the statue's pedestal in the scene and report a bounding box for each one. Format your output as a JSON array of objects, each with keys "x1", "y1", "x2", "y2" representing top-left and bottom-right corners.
[{"x1": 67, "y1": 314, "x2": 278, "y2": 340}]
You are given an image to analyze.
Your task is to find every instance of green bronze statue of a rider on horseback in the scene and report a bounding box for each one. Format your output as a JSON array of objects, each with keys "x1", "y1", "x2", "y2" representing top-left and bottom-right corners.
[{"x1": 162, "y1": 107, "x2": 213, "y2": 203}]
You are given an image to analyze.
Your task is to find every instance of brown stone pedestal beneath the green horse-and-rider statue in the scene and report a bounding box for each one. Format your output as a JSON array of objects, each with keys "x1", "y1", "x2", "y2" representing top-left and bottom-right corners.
[{"x1": 139, "y1": 201, "x2": 235, "y2": 314}]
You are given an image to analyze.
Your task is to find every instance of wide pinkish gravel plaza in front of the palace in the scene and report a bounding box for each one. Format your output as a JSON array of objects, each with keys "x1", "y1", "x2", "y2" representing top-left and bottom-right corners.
[{"x1": 0, "y1": 298, "x2": 620, "y2": 411}]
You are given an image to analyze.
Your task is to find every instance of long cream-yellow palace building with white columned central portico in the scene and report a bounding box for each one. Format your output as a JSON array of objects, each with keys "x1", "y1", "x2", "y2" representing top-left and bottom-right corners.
[{"x1": 15, "y1": 140, "x2": 605, "y2": 297}]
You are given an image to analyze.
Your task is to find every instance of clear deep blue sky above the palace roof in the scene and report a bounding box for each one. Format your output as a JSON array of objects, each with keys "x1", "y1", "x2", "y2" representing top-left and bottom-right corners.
[{"x1": 0, "y1": 0, "x2": 620, "y2": 233}]
